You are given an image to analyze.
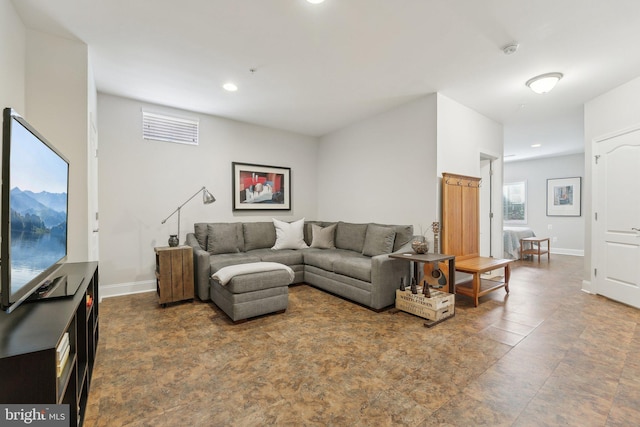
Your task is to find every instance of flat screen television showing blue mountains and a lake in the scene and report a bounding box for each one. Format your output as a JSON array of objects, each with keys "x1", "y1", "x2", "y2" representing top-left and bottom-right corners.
[{"x1": 0, "y1": 108, "x2": 73, "y2": 313}]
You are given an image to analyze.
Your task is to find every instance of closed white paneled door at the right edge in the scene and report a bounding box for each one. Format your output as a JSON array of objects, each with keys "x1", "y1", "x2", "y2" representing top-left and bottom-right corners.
[{"x1": 592, "y1": 128, "x2": 640, "y2": 308}]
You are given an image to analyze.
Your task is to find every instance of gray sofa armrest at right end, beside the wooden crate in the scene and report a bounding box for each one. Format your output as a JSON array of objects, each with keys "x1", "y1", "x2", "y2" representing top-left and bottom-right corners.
[{"x1": 371, "y1": 243, "x2": 411, "y2": 310}]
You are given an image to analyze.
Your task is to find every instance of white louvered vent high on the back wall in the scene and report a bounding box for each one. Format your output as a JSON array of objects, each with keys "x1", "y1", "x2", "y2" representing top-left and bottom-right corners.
[{"x1": 142, "y1": 111, "x2": 199, "y2": 145}]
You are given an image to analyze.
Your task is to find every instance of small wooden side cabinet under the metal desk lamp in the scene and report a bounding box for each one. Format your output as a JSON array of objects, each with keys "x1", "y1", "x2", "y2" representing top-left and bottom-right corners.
[{"x1": 155, "y1": 246, "x2": 195, "y2": 307}]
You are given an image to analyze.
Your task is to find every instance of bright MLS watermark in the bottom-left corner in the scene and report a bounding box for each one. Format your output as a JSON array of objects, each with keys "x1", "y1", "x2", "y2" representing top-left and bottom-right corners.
[{"x1": 0, "y1": 405, "x2": 71, "y2": 427}]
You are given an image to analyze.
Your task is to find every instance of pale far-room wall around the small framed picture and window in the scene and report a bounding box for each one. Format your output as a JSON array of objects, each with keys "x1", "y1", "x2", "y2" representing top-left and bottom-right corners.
[{"x1": 504, "y1": 154, "x2": 585, "y2": 255}]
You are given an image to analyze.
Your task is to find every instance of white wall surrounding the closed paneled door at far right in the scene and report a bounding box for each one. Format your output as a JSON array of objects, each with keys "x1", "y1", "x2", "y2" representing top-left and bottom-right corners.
[{"x1": 582, "y1": 77, "x2": 640, "y2": 292}]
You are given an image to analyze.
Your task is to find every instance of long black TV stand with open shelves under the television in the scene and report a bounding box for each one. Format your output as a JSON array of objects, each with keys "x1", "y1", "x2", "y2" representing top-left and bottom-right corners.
[{"x1": 0, "y1": 262, "x2": 99, "y2": 426}]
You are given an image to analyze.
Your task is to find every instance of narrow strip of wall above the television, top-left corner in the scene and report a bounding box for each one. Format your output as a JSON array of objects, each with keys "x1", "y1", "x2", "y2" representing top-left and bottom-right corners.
[{"x1": 0, "y1": 0, "x2": 27, "y2": 114}]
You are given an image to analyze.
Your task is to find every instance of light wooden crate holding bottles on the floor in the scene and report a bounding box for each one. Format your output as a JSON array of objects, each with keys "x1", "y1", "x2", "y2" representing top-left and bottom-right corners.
[{"x1": 396, "y1": 288, "x2": 455, "y2": 321}]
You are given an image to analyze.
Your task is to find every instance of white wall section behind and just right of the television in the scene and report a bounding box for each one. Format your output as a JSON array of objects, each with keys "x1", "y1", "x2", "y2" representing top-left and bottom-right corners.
[{"x1": 23, "y1": 30, "x2": 89, "y2": 262}]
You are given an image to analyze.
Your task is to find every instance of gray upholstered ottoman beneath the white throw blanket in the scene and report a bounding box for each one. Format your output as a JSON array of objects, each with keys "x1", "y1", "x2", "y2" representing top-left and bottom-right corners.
[{"x1": 209, "y1": 263, "x2": 293, "y2": 322}]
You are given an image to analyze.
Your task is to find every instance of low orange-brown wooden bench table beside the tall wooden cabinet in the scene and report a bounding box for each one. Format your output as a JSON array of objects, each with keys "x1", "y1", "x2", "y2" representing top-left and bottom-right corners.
[{"x1": 455, "y1": 257, "x2": 513, "y2": 307}]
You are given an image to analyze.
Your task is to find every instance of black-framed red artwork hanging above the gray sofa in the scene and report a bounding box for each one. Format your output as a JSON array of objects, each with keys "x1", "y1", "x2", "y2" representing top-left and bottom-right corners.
[{"x1": 231, "y1": 162, "x2": 291, "y2": 211}]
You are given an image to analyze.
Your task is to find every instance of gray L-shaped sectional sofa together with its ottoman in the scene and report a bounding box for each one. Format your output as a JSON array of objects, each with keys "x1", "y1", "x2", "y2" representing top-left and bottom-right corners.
[{"x1": 187, "y1": 220, "x2": 413, "y2": 321}]
